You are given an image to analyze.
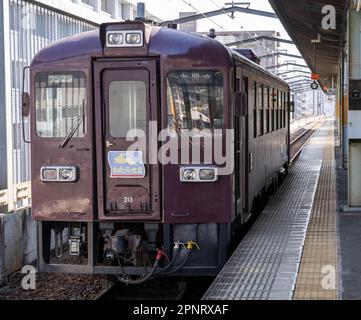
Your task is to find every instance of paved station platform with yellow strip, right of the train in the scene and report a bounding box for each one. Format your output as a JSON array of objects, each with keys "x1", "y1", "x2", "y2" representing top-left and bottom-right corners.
[{"x1": 203, "y1": 119, "x2": 346, "y2": 300}]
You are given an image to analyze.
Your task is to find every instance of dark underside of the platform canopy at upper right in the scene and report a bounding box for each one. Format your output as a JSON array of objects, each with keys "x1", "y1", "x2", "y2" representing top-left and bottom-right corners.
[{"x1": 269, "y1": 0, "x2": 350, "y2": 87}]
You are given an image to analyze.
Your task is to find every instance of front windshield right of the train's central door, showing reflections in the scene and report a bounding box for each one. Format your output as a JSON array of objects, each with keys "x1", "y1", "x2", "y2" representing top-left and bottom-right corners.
[{"x1": 167, "y1": 71, "x2": 224, "y2": 130}]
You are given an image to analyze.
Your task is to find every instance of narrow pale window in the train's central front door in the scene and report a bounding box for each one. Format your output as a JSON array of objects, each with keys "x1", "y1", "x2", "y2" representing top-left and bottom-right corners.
[{"x1": 109, "y1": 81, "x2": 147, "y2": 138}]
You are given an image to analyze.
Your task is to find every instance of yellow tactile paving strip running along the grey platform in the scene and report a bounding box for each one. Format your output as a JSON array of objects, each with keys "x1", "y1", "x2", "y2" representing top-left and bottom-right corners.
[{"x1": 293, "y1": 129, "x2": 338, "y2": 300}]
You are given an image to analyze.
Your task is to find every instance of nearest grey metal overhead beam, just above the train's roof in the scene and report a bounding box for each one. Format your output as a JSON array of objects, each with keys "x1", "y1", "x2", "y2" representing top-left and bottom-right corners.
[{"x1": 159, "y1": 6, "x2": 278, "y2": 26}]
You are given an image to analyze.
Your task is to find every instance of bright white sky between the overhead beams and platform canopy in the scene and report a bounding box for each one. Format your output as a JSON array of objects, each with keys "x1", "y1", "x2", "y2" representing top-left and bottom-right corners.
[{"x1": 142, "y1": 0, "x2": 304, "y2": 64}]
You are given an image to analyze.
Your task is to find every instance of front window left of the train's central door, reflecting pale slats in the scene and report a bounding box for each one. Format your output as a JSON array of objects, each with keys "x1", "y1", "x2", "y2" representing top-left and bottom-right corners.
[{"x1": 35, "y1": 72, "x2": 87, "y2": 138}]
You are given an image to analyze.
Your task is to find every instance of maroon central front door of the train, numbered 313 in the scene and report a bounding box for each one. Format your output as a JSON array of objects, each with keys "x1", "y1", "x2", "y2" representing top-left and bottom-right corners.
[{"x1": 95, "y1": 61, "x2": 160, "y2": 221}]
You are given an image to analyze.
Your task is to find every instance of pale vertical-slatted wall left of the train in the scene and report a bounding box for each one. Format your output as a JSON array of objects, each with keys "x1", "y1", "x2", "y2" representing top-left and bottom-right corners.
[{"x1": 4, "y1": 0, "x2": 97, "y2": 209}]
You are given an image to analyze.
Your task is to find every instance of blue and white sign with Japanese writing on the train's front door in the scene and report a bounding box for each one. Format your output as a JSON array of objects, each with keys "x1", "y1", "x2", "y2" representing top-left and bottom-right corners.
[{"x1": 108, "y1": 151, "x2": 145, "y2": 179}]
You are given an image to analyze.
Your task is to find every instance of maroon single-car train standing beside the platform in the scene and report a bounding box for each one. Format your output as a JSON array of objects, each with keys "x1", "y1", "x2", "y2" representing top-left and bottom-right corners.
[{"x1": 23, "y1": 22, "x2": 290, "y2": 283}]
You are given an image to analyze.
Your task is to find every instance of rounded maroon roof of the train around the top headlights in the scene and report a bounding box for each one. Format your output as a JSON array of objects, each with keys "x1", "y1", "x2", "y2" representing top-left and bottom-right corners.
[{"x1": 31, "y1": 22, "x2": 288, "y2": 86}]
